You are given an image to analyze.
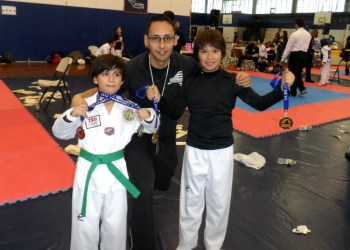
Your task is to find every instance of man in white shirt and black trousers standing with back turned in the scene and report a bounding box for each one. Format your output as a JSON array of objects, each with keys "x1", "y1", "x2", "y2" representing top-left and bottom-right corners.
[{"x1": 281, "y1": 17, "x2": 311, "y2": 96}]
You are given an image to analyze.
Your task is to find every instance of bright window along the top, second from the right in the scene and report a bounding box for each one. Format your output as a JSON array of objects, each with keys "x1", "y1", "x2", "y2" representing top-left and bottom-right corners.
[{"x1": 255, "y1": 0, "x2": 292, "y2": 14}]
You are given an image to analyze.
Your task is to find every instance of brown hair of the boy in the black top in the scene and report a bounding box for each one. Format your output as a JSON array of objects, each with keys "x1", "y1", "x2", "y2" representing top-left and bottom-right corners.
[{"x1": 193, "y1": 29, "x2": 226, "y2": 58}]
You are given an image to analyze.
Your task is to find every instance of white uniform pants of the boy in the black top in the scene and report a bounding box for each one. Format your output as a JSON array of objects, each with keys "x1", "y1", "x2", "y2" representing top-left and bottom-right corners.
[{"x1": 178, "y1": 145, "x2": 233, "y2": 250}]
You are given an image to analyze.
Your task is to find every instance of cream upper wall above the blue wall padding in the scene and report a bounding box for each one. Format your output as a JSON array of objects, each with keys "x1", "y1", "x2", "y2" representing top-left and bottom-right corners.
[{"x1": 2, "y1": 0, "x2": 191, "y2": 16}]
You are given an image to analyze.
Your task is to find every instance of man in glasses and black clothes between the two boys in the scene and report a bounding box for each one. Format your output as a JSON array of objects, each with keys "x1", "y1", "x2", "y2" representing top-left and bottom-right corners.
[{"x1": 72, "y1": 15, "x2": 250, "y2": 250}]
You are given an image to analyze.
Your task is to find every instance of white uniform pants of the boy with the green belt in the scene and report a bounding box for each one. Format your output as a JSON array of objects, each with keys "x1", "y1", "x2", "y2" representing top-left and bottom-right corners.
[{"x1": 71, "y1": 182, "x2": 127, "y2": 250}]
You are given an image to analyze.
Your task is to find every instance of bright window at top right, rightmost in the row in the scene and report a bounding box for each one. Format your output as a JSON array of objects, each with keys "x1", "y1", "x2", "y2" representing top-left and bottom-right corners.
[{"x1": 296, "y1": 0, "x2": 345, "y2": 13}]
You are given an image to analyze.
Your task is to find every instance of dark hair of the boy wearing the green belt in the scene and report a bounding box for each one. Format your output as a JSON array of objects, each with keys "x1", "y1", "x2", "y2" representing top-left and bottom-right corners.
[{"x1": 90, "y1": 54, "x2": 125, "y2": 79}]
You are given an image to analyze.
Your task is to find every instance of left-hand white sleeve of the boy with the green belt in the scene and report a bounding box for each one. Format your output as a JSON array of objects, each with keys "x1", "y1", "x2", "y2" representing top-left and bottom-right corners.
[{"x1": 52, "y1": 108, "x2": 81, "y2": 140}]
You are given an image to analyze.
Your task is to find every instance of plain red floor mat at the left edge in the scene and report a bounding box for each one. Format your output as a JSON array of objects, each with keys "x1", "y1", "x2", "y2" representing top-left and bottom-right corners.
[{"x1": 0, "y1": 80, "x2": 75, "y2": 205}]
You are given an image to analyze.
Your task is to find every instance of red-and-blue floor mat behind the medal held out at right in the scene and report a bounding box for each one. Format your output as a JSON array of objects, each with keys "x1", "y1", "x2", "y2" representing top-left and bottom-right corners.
[{"x1": 228, "y1": 71, "x2": 350, "y2": 138}]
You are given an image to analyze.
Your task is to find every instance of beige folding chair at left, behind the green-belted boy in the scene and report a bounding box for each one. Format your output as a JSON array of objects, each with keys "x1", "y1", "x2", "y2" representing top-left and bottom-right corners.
[{"x1": 38, "y1": 57, "x2": 73, "y2": 110}]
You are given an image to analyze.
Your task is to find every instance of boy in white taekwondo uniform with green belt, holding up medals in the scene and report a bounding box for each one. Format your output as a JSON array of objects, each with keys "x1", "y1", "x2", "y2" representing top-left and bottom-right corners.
[{"x1": 52, "y1": 55, "x2": 158, "y2": 250}]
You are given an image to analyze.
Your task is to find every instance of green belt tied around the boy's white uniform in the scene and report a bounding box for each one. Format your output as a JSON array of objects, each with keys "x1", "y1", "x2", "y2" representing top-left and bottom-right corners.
[{"x1": 79, "y1": 149, "x2": 140, "y2": 217}]
